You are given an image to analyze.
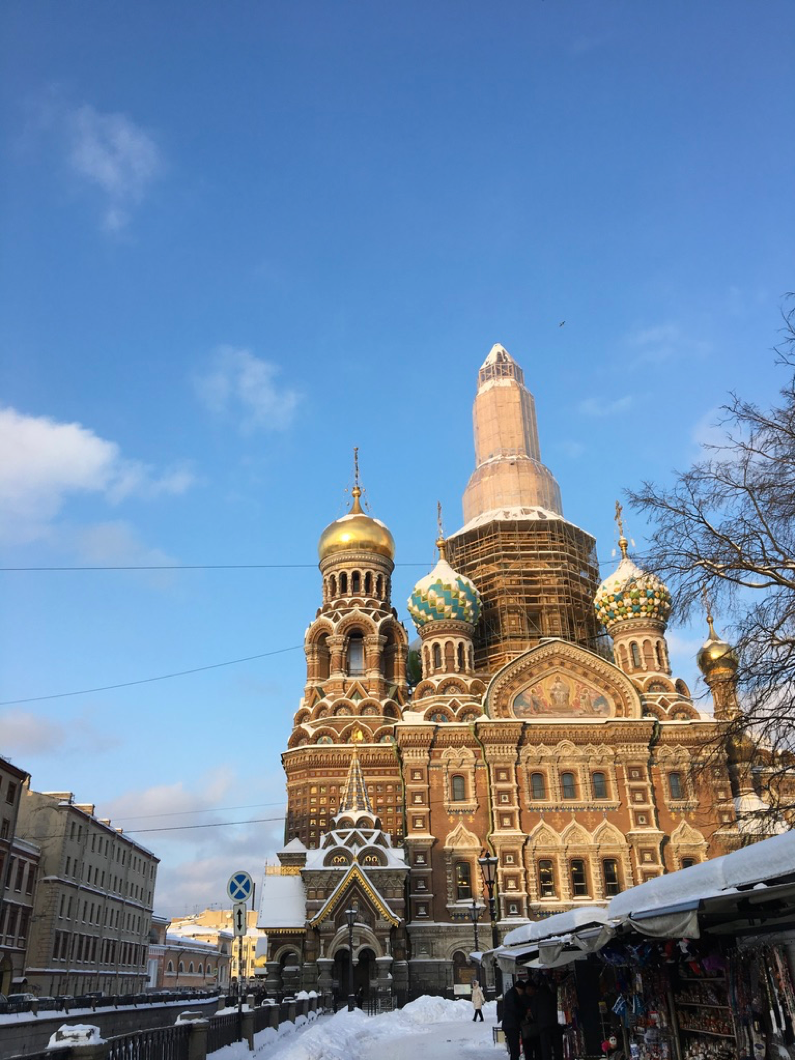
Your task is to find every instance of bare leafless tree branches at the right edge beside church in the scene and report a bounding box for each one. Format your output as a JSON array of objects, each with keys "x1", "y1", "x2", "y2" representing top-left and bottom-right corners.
[{"x1": 629, "y1": 296, "x2": 795, "y2": 817}]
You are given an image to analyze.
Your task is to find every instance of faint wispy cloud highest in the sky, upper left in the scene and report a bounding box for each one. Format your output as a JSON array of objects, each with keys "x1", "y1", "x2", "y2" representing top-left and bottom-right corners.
[{"x1": 66, "y1": 104, "x2": 163, "y2": 231}]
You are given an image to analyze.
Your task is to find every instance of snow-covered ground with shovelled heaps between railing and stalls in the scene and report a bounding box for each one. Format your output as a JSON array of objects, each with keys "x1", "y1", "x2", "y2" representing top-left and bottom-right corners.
[{"x1": 212, "y1": 997, "x2": 506, "y2": 1060}]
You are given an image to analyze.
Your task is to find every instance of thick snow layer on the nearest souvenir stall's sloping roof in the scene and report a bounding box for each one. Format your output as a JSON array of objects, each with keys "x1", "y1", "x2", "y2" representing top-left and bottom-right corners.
[{"x1": 607, "y1": 832, "x2": 795, "y2": 917}]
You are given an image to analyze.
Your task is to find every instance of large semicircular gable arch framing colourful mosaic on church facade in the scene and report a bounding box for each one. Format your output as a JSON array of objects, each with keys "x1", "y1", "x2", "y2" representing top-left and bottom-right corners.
[{"x1": 483, "y1": 639, "x2": 642, "y2": 721}]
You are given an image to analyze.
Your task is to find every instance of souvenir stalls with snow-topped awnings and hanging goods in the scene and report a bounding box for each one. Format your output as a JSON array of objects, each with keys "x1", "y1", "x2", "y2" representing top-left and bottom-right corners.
[{"x1": 484, "y1": 833, "x2": 795, "y2": 1060}]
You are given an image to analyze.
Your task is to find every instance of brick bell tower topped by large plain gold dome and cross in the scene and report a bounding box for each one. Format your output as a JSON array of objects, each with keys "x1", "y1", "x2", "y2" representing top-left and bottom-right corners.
[{"x1": 282, "y1": 449, "x2": 408, "y2": 848}]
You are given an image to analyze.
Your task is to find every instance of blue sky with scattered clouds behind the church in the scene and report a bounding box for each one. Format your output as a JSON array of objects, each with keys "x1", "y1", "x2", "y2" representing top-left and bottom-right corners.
[{"x1": 0, "y1": 0, "x2": 795, "y2": 914}]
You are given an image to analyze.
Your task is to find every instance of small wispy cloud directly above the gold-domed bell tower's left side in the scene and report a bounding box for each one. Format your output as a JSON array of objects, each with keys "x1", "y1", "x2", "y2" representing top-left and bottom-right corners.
[{"x1": 194, "y1": 346, "x2": 301, "y2": 432}]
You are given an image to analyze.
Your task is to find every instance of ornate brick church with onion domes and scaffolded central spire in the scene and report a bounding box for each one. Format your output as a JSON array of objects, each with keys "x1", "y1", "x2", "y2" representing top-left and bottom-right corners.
[{"x1": 259, "y1": 345, "x2": 753, "y2": 1003}]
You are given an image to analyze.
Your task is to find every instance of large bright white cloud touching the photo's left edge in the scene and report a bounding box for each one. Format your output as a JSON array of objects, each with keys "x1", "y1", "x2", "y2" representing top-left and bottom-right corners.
[{"x1": 0, "y1": 408, "x2": 193, "y2": 543}]
